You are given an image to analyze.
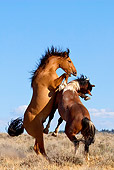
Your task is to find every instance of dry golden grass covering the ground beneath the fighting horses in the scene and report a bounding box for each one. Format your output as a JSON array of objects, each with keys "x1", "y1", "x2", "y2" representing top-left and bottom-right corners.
[{"x1": 0, "y1": 133, "x2": 114, "y2": 170}]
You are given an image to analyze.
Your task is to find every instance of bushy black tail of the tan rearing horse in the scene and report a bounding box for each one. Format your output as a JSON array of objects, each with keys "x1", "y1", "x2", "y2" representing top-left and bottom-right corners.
[{"x1": 7, "y1": 118, "x2": 24, "y2": 136}]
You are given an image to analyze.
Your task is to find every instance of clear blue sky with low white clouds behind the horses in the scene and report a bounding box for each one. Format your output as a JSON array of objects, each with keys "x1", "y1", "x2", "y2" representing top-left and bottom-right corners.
[{"x1": 0, "y1": 0, "x2": 114, "y2": 132}]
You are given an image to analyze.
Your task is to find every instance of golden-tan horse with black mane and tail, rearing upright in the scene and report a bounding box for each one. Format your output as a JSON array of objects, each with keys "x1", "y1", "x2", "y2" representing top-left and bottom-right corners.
[{"x1": 8, "y1": 46, "x2": 77, "y2": 157}]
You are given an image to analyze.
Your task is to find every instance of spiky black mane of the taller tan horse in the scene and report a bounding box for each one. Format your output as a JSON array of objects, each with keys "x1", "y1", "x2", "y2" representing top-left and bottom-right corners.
[{"x1": 31, "y1": 46, "x2": 70, "y2": 87}]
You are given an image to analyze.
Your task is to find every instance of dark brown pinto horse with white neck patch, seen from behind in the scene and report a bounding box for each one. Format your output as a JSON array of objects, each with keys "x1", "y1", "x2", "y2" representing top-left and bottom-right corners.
[{"x1": 43, "y1": 76, "x2": 95, "y2": 159}]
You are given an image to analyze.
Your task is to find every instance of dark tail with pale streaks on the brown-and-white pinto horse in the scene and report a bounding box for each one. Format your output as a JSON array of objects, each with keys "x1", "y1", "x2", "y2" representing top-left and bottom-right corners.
[{"x1": 82, "y1": 117, "x2": 96, "y2": 145}]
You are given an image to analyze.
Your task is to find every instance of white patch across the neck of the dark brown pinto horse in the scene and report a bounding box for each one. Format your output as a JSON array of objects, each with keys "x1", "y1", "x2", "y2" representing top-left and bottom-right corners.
[{"x1": 63, "y1": 80, "x2": 80, "y2": 93}]
